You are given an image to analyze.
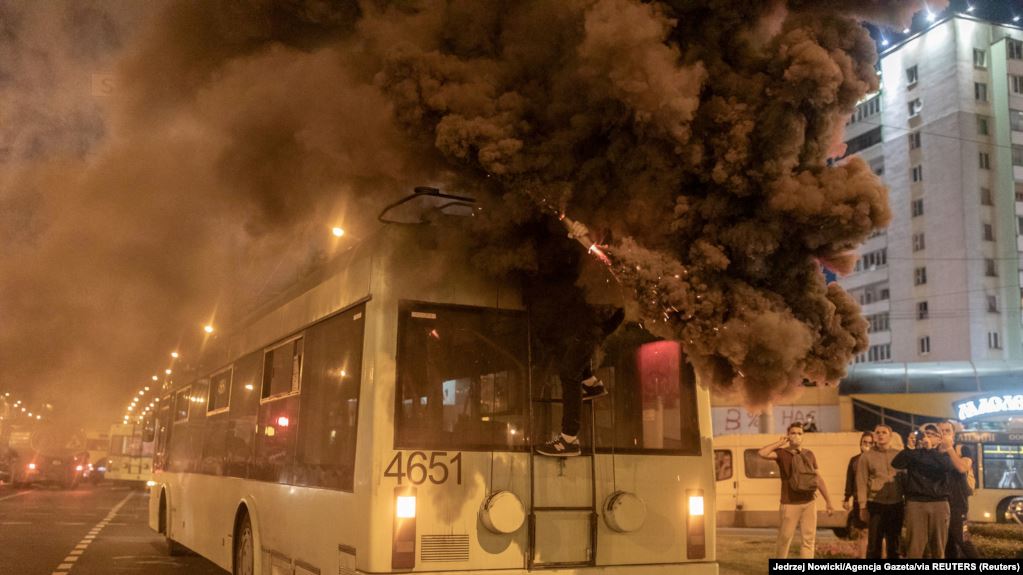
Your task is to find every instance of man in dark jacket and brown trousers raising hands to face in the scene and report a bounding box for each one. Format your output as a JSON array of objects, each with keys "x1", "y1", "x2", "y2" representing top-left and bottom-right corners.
[{"x1": 892, "y1": 424, "x2": 954, "y2": 559}]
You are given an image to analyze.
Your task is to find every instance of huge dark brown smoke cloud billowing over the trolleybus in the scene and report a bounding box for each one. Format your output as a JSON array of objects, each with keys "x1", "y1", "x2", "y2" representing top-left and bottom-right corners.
[{"x1": 0, "y1": 0, "x2": 920, "y2": 421}]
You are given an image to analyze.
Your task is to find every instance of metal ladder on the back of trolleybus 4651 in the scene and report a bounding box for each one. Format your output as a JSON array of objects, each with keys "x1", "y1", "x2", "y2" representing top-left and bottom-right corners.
[{"x1": 527, "y1": 398, "x2": 597, "y2": 571}]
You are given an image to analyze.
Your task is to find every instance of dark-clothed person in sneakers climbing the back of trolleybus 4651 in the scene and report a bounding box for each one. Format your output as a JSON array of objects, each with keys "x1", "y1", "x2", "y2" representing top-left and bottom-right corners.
[{"x1": 536, "y1": 308, "x2": 625, "y2": 457}]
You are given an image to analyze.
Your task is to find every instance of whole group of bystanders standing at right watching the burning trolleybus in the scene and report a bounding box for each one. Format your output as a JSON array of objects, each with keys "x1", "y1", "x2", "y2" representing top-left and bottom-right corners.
[{"x1": 758, "y1": 421, "x2": 979, "y2": 559}]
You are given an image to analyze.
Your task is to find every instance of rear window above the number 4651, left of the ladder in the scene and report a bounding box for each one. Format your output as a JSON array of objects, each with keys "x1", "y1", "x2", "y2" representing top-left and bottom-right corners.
[{"x1": 395, "y1": 303, "x2": 528, "y2": 450}]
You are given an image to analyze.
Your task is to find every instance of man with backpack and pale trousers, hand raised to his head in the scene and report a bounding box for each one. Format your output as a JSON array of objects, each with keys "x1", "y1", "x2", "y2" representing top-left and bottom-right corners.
[{"x1": 757, "y1": 423, "x2": 835, "y2": 559}]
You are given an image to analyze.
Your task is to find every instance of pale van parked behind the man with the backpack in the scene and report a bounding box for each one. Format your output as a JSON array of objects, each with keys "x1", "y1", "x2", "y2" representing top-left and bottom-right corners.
[{"x1": 714, "y1": 432, "x2": 861, "y2": 537}]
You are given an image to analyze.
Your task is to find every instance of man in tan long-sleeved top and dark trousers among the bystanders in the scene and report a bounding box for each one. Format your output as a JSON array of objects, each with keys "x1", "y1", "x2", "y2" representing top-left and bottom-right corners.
[{"x1": 856, "y1": 424, "x2": 904, "y2": 559}]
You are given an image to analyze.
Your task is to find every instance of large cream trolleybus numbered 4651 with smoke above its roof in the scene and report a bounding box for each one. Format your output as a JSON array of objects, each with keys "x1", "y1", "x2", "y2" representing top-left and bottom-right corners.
[{"x1": 149, "y1": 226, "x2": 717, "y2": 575}]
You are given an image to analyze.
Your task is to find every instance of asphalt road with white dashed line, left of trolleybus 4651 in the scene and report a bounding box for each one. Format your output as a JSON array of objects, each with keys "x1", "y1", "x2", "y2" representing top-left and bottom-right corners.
[{"x1": 0, "y1": 485, "x2": 226, "y2": 575}]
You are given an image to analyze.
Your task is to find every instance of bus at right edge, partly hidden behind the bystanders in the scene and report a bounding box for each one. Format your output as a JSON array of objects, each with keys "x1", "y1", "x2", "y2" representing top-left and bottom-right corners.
[{"x1": 955, "y1": 430, "x2": 1023, "y2": 523}]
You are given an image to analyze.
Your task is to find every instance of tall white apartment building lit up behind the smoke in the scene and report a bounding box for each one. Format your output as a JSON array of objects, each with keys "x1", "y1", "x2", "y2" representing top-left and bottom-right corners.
[{"x1": 840, "y1": 14, "x2": 1023, "y2": 362}]
